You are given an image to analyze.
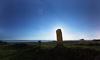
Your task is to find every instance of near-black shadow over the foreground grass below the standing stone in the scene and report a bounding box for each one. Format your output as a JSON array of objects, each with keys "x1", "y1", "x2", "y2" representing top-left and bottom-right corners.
[{"x1": 10, "y1": 45, "x2": 100, "y2": 60}]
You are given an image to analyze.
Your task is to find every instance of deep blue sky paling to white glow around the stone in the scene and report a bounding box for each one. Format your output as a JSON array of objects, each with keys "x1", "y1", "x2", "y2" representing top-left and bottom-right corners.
[{"x1": 0, "y1": 0, "x2": 100, "y2": 40}]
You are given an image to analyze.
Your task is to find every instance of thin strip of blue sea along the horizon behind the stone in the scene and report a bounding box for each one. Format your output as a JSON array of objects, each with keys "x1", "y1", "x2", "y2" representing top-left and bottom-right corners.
[{"x1": 0, "y1": 40, "x2": 78, "y2": 43}]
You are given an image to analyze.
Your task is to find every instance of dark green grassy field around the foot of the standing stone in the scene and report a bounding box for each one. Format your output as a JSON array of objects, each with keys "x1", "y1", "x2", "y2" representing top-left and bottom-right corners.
[{"x1": 0, "y1": 41, "x2": 100, "y2": 60}]
